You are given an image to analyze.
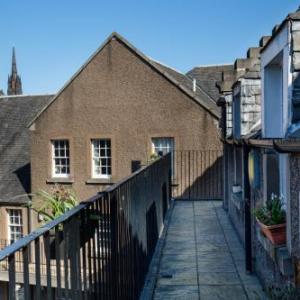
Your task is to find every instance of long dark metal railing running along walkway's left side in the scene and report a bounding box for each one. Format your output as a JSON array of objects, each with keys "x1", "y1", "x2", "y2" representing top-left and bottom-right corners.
[{"x1": 0, "y1": 154, "x2": 172, "y2": 300}]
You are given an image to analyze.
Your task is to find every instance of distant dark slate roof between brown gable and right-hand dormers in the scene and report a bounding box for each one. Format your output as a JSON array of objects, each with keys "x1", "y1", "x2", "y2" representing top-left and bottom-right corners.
[{"x1": 186, "y1": 65, "x2": 234, "y2": 101}]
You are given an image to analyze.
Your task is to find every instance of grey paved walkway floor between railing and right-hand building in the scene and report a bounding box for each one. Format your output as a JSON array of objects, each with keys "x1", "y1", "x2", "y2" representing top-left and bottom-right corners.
[{"x1": 154, "y1": 201, "x2": 266, "y2": 300}]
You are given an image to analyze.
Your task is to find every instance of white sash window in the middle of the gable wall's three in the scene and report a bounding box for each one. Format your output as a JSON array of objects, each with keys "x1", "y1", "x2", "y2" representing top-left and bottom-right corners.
[{"x1": 91, "y1": 139, "x2": 111, "y2": 178}]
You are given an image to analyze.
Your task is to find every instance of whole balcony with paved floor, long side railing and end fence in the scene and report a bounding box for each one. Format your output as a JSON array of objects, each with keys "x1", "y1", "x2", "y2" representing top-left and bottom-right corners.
[{"x1": 0, "y1": 151, "x2": 259, "y2": 300}]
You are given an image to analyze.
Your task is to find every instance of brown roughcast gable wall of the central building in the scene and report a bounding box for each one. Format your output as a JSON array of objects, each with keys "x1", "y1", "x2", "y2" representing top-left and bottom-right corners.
[{"x1": 31, "y1": 40, "x2": 222, "y2": 230}]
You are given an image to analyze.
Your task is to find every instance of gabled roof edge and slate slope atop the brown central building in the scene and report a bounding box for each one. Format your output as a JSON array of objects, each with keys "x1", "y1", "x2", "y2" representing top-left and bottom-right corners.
[{"x1": 28, "y1": 32, "x2": 220, "y2": 126}]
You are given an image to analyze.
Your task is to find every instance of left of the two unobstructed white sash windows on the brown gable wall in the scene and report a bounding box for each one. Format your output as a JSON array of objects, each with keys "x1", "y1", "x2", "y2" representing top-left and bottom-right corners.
[{"x1": 52, "y1": 140, "x2": 70, "y2": 177}]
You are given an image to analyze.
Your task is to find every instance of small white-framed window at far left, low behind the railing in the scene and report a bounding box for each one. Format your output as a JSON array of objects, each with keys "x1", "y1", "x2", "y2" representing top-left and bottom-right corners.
[{"x1": 7, "y1": 209, "x2": 23, "y2": 243}]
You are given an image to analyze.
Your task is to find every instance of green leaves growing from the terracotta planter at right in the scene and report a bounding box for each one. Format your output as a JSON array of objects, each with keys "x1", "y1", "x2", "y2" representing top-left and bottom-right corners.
[{"x1": 253, "y1": 195, "x2": 286, "y2": 226}]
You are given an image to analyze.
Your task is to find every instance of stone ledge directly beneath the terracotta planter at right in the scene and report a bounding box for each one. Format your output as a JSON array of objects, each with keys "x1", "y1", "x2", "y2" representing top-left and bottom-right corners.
[{"x1": 256, "y1": 225, "x2": 294, "y2": 276}]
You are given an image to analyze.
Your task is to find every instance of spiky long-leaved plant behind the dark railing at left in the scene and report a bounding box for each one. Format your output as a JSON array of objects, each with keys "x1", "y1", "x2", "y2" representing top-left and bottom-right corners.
[{"x1": 28, "y1": 185, "x2": 78, "y2": 259}]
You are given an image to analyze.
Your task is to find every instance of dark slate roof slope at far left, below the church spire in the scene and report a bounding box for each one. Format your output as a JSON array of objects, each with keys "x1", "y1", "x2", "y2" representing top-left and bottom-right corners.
[{"x1": 0, "y1": 95, "x2": 53, "y2": 203}]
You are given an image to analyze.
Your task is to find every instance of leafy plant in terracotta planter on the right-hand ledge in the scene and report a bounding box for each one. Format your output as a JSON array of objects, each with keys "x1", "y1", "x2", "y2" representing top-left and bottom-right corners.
[{"x1": 254, "y1": 194, "x2": 286, "y2": 245}]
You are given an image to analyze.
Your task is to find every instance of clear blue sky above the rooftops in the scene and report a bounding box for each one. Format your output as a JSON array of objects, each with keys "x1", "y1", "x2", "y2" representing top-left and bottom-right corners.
[{"x1": 0, "y1": 0, "x2": 300, "y2": 94}]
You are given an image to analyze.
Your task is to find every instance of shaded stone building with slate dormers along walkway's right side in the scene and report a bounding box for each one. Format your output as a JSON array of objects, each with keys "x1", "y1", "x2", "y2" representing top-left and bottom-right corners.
[{"x1": 218, "y1": 7, "x2": 300, "y2": 288}]
